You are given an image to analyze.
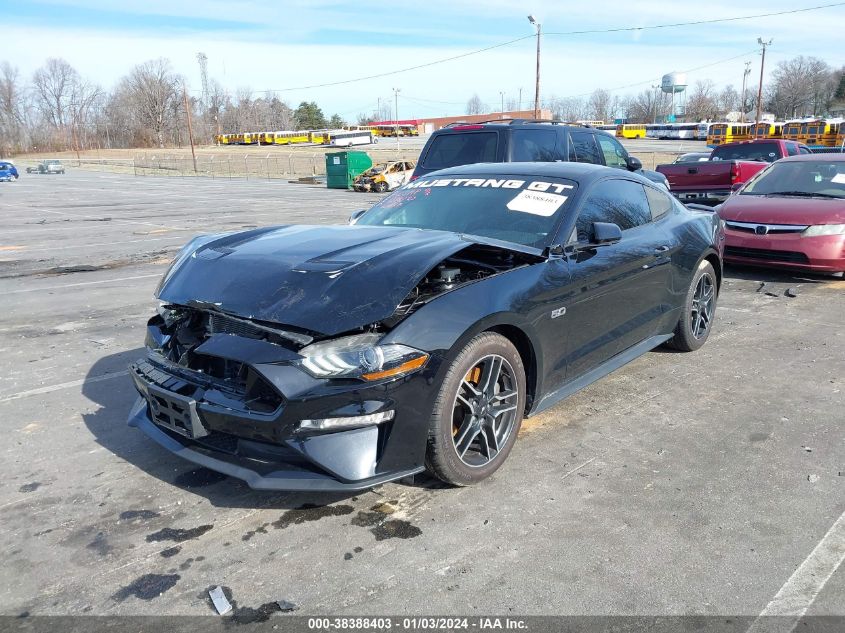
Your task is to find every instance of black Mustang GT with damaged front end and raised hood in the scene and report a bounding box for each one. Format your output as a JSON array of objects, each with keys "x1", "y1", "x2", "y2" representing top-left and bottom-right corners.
[{"x1": 129, "y1": 163, "x2": 724, "y2": 490}]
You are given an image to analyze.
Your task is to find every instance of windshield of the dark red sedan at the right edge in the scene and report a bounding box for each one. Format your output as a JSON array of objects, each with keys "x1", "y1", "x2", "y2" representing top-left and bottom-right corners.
[{"x1": 740, "y1": 160, "x2": 845, "y2": 198}]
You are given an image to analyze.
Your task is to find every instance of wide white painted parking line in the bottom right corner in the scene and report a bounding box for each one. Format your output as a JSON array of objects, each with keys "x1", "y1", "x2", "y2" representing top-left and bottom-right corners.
[{"x1": 747, "y1": 512, "x2": 845, "y2": 633}]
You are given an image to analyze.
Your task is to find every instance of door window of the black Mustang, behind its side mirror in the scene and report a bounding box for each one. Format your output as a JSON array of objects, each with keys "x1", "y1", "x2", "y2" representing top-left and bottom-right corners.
[{"x1": 575, "y1": 180, "x2": 651, "y2": 242}]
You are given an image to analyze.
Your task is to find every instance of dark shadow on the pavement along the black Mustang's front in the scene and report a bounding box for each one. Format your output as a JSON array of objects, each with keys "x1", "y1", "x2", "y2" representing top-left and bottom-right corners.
[{"x1": 82, "y1": 349, "x2": 366, "y2": 509}]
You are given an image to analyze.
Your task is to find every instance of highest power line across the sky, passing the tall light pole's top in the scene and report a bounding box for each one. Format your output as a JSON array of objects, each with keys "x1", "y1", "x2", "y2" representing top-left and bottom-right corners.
[{"x1": 255, "y1": 2, "x2": 845, "y2": 92}]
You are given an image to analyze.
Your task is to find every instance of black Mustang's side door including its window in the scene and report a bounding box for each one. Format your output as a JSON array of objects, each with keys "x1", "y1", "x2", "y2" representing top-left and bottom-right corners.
[{"x1": 565, "y1": 178, "x2": 671, "y2": 380}]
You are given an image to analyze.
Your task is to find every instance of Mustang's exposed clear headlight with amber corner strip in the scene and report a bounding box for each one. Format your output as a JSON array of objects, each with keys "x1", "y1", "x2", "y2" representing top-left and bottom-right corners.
[{"x1": 295, "y1": 334, "x2": 428, "y2": 380}]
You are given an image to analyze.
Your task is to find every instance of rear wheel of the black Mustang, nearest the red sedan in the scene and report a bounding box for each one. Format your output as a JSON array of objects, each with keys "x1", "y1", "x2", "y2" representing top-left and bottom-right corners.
[{"x1": 666, "y1": 259, "x2": 719, "y2": 352}]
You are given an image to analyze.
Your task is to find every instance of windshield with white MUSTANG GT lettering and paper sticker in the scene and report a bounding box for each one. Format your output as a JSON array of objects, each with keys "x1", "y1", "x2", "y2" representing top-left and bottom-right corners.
[{"x1": 358, "y1": 176, "x2": 577, "y2": 248}]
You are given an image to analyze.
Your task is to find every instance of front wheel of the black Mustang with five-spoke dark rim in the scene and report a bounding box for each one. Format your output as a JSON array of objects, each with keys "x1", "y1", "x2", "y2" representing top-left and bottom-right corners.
[{"x1": 426, "y1": 332, "x2": 525, "y2": 486}]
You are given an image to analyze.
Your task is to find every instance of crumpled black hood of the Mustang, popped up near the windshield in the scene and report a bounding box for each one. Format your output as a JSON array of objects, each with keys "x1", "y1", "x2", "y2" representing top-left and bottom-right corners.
[{"x1": 158, "y1": 226, "x2": 472, "y2": 336}]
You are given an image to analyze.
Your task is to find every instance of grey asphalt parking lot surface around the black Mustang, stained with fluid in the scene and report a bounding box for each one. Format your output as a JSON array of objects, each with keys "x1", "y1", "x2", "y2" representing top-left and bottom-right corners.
[{"x1": 0, "y1": 171, "x2": 845, "y2": 616}]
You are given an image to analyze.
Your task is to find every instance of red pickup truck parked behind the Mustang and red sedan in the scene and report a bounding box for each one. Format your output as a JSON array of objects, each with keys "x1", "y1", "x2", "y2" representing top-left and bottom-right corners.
[{"x1": 657, "y1": 139, "x2": 810, "y2": 205}]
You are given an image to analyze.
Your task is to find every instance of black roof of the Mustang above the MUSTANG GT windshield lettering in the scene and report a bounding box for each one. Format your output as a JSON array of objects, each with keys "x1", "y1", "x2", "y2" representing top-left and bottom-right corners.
[{"x1": 422, "y1": 162, "x2": 653, "y2": 184}]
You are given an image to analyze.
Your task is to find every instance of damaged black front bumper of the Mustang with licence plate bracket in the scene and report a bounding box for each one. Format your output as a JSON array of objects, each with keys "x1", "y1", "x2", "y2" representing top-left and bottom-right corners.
[{"x1": 128, "y1": 336, "x2": 437, "y2": 491}]
